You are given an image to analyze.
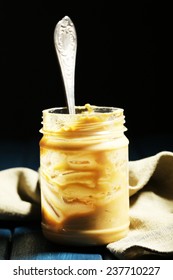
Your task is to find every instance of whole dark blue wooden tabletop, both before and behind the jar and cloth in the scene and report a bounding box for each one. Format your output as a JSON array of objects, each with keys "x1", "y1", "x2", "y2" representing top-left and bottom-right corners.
[{"x1": 0, "y1": 134, "x2": 173, "y2": 260}]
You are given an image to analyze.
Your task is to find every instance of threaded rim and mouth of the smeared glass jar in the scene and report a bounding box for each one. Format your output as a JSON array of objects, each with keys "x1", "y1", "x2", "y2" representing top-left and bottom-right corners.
[{"x1": 41, "y1": 104, "x2": 126, "y2": 136}]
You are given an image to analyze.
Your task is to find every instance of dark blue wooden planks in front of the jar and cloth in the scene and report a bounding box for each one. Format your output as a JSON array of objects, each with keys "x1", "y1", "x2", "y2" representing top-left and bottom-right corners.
[{"x1": 0, "y1": 222, "x2": 115, "y2": 260}]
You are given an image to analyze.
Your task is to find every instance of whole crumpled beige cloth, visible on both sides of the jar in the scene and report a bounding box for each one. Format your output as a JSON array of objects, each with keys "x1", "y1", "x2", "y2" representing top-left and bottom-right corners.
[{"x1": 0, "y1": 151, "x2": 173, "y2": 259}]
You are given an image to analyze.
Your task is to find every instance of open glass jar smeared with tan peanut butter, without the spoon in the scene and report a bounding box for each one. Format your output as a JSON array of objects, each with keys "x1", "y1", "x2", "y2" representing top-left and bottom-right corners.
[{"x1": 40, "y1": 104, "x2": 129, "y2": 245}]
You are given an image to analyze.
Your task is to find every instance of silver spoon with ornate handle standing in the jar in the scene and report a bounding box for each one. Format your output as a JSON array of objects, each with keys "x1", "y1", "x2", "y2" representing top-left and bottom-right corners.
[{"x1": 54, "y1": 16, "x2": 77, "y2": 114}]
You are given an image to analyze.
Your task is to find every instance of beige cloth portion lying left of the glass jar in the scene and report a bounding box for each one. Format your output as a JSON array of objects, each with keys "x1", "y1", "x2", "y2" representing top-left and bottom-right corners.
[{"x1": 0, "y1": 167, "x2": 40, "y2": 220}]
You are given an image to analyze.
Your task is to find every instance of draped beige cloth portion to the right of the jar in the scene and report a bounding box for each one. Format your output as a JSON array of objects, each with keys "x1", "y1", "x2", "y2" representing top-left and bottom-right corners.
[{"x1": 107, "y1": 151, "x2": 173, "y2": 259}]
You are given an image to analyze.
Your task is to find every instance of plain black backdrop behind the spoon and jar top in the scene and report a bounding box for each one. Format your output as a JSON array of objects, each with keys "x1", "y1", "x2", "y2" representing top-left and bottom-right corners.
[{"x1": 0, "y1": 0, "x2": 172, "y2": 142}]
